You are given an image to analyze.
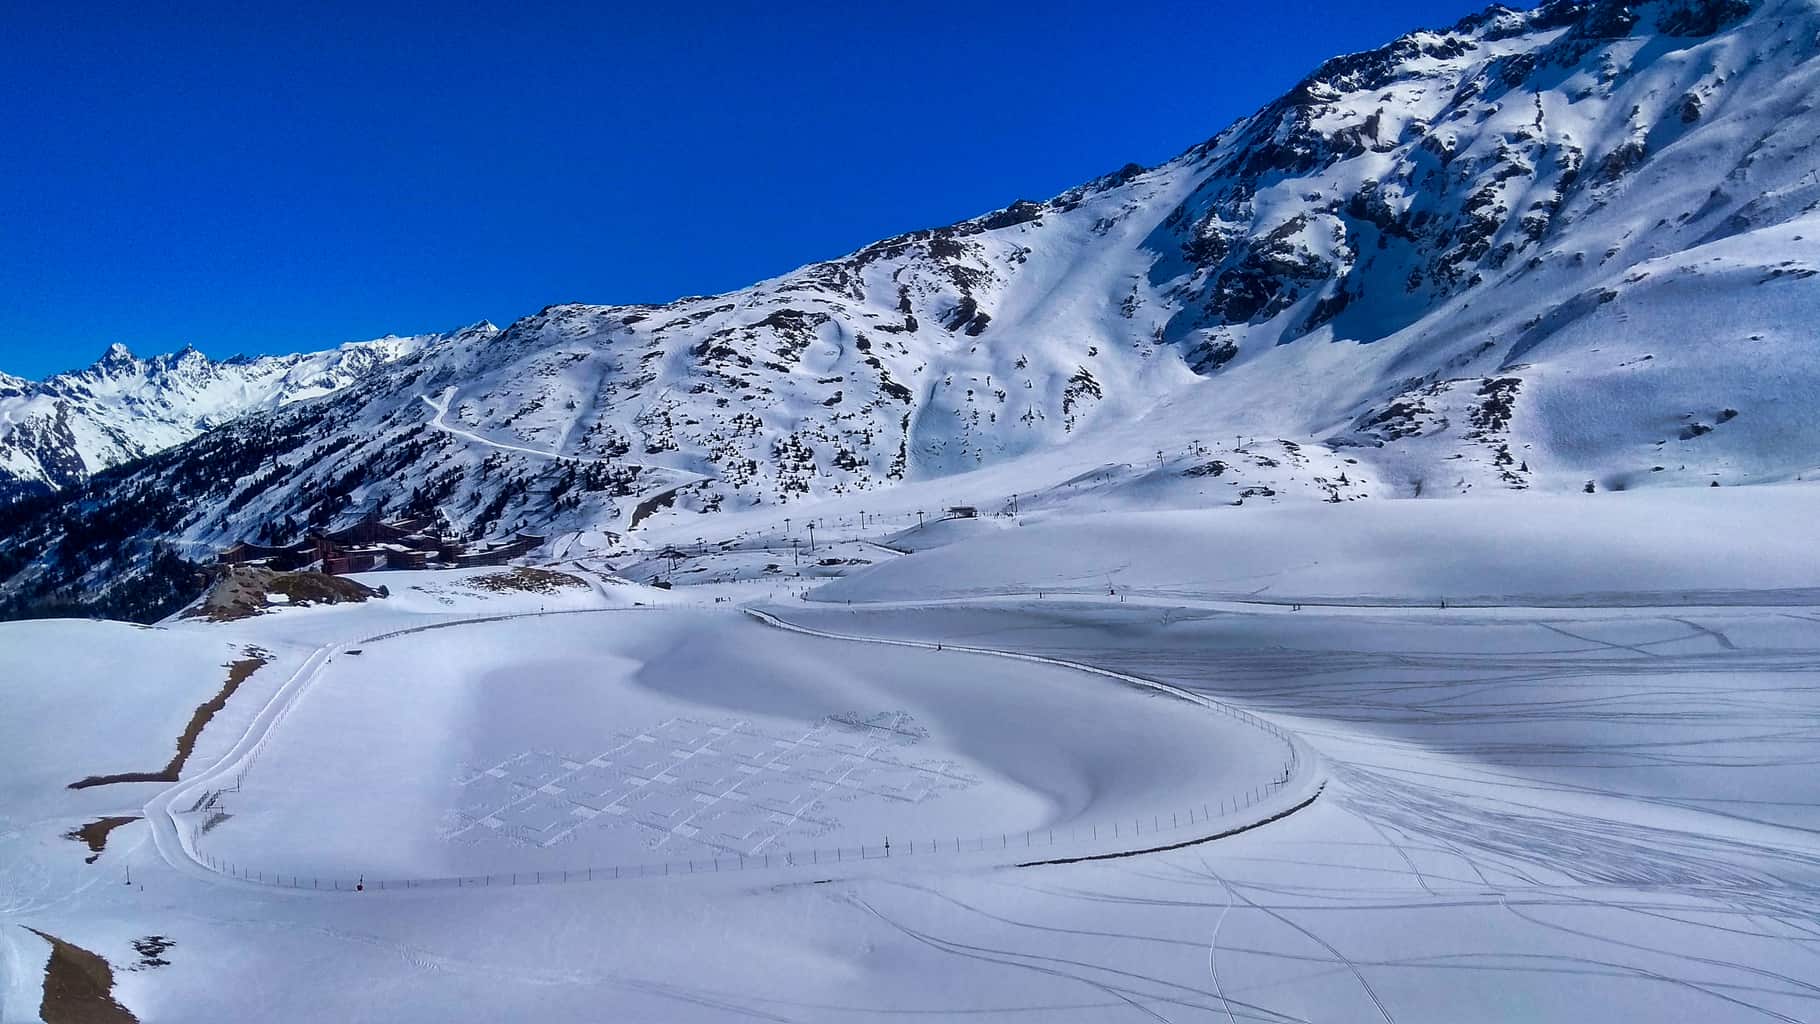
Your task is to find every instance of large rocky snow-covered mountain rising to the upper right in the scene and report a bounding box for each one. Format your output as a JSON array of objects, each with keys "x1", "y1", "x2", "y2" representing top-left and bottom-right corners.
[{"x1": 0, "y1": 0, "x2": 1820, "y2": 625}]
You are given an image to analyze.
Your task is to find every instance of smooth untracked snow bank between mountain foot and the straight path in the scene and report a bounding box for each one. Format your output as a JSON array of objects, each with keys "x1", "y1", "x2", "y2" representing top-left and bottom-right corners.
[{"x1": 812, "y1": 486, "x2": 1820, "y2": 606}]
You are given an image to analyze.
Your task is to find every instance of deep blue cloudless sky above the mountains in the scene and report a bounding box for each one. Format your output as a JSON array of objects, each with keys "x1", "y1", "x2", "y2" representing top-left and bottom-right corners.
[{"x1": 0, "y1": 0, "x2": 1506, "y2": 376}]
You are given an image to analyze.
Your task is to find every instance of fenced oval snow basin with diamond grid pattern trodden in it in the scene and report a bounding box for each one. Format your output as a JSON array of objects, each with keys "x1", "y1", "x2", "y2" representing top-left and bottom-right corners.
[{"x1": 177, "y1": 611, "x2": 1290, "y2": 888}]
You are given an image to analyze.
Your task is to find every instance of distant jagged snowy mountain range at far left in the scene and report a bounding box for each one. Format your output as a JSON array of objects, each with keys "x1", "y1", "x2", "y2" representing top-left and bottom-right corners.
[{"x1": 0, "y1": 324, "x2": 495, "y2": 495}]
